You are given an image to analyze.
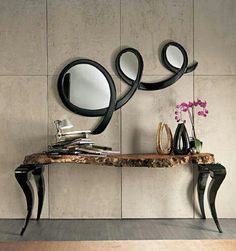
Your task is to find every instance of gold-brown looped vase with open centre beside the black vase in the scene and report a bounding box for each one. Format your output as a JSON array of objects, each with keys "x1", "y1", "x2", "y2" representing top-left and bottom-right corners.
[{"x1": 157, "y1": 122, "x2": 173, "y2": 154}]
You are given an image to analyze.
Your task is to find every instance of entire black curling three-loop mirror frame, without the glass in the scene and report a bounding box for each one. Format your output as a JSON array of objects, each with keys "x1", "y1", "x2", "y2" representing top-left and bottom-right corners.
[{"x1": 58, "y1": 42, "x2": 198, "y2": 134}]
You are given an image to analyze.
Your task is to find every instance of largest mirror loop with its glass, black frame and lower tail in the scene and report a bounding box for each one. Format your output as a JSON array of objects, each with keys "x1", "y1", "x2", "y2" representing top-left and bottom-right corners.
[{"x1": 58, "y1": 59, "x2": 116, "y2": 134}]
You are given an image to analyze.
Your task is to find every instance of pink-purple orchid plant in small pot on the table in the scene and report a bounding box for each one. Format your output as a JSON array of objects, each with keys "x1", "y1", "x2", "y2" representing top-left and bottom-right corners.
[{"x1": 175, "y1": 99, "x2": 209, "y2": 153}]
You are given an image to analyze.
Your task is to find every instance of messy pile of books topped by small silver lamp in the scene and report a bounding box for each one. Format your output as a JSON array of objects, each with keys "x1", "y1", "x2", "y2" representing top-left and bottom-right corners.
[{"x1": 50, "y1": 119, "x2": 120, "y2": 155}]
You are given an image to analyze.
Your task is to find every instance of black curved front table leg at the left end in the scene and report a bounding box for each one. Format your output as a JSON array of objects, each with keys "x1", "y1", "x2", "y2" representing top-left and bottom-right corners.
[{"x1": 15, "y1": 165, "x2": 34, "y2": 235}]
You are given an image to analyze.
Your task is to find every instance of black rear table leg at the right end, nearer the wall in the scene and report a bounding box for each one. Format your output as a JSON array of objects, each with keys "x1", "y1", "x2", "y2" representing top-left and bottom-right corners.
[{"x1": 197, "y1": 166, "x2": 209, "y2": 219}]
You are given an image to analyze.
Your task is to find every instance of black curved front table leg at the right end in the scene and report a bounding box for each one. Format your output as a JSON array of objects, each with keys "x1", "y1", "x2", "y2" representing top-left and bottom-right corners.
[{"x1": 208, "y1": 164, "x2": 226, "y2": 233}]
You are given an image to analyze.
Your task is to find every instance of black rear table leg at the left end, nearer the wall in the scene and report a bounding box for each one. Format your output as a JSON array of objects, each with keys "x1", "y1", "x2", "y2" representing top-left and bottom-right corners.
[{"x1": 32, "y1": 166, "x2": 45, "y2": 221}]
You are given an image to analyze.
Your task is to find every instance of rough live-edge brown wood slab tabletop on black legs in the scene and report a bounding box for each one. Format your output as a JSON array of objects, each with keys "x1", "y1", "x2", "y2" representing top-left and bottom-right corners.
[{"x1": 24, "y1": 153, "x2": 215, "y2": 168}]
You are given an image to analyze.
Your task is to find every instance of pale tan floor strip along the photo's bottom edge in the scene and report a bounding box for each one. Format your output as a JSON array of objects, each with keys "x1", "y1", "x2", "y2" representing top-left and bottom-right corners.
[{"x1": 0, "y1": 240, "x2": 236, "y2": 251}]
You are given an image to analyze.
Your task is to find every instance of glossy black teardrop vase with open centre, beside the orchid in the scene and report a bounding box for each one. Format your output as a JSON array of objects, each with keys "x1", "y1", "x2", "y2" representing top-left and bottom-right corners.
[{"x1": 173, "y1": 123, "x2": 190, "y2": 155}]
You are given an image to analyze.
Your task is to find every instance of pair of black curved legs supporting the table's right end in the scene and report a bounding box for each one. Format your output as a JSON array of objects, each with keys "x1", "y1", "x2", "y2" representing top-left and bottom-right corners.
[{"x1": 198, "y1": 164, "x2": 226, "y2": 233}]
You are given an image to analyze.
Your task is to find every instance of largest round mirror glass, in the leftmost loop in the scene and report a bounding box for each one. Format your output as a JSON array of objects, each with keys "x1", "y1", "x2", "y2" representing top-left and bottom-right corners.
[{"x1": 64, "y1": 64, "x2": 110, "y2": 110}]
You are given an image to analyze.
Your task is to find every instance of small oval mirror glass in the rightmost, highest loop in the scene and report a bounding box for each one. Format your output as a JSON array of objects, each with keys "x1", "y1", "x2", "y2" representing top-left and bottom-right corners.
[{"x1": 166, "y1": 45, "x2": 184, "y2": 68}]
